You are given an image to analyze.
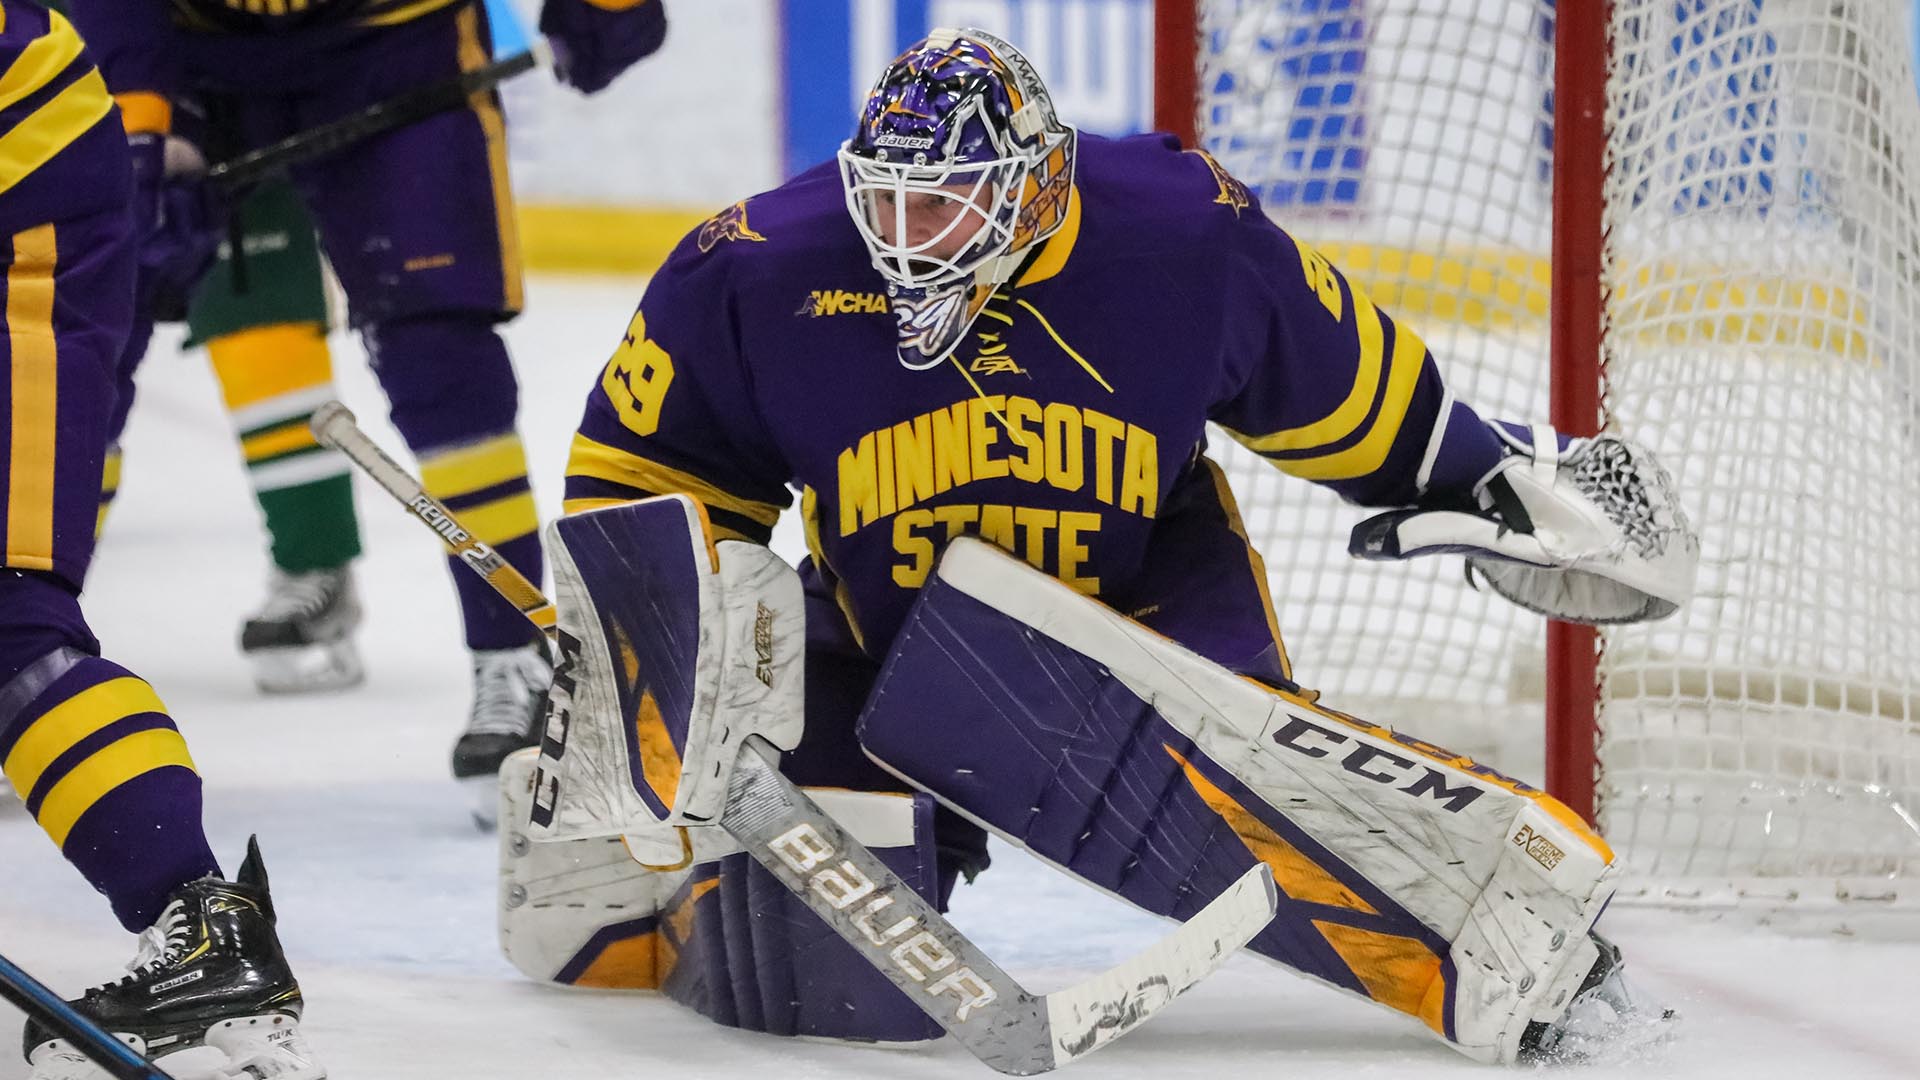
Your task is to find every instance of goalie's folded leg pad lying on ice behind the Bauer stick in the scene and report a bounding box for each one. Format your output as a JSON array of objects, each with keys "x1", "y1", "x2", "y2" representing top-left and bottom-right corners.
[{"x1": 499, "y1": 749, "x2": 941, "y2": 1043}]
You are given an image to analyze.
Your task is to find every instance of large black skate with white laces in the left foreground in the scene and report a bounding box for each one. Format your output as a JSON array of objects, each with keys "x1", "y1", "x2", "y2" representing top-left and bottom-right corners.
[{"x1": 25, "y1": 840, "x2": 326, "y2": 1080}]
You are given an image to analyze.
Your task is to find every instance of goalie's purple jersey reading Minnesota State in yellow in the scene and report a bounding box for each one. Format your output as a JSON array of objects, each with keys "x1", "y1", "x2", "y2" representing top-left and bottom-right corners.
[{"x1": 566, "y1": 135, "x2": 1501, "y2": 655}]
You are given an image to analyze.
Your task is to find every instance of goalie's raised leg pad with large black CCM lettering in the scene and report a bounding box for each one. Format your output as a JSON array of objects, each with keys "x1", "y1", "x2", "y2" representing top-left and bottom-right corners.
[{"x1": 860, "y1": 540, "x2": 1666, "y2": 1061}]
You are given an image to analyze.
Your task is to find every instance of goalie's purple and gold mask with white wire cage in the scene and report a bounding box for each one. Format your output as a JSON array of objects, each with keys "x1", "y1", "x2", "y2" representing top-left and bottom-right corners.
[{"x1": 839, "y1": 29, "x2": 1075, "y2": 371}]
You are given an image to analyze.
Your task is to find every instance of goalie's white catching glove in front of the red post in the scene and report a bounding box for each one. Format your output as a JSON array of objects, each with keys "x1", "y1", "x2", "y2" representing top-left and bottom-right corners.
[{"x1": 1348, "y1": 423, "x2": 1699, "y2": 625}]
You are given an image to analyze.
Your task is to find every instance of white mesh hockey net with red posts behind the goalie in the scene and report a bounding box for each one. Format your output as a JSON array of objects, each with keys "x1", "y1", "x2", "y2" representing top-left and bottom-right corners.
[{"x1": 1156, "y1": 0, "x2": 1920, "y2": 922}]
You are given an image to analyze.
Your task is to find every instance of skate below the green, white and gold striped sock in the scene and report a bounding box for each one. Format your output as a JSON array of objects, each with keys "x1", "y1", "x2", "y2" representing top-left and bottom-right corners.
[{"x1": 240, "y1": 567, "x2": 365, "y2": 694}]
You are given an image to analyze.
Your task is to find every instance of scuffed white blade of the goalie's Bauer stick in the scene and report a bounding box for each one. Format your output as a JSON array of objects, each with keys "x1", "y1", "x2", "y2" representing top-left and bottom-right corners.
[{"x1": 1046, "y1": 863, "x2": 1279, "y2": 1068}]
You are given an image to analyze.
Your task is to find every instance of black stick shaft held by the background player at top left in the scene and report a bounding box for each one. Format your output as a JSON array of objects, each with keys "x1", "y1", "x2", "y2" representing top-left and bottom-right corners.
[{"x1": 207, "y1": 40, "x2": 553, "y2": 194}]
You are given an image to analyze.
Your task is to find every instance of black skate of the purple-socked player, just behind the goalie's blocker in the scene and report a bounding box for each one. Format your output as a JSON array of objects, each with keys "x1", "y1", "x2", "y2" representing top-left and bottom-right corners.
[{"x1": 453, "y1": 638, "x2": 553, "y2": 830}]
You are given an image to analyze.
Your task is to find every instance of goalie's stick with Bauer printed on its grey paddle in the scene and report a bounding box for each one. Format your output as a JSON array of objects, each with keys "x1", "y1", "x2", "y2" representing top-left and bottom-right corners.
[{"x1": 313, "y1": 402, "x2": 1279, "y2": 1076}]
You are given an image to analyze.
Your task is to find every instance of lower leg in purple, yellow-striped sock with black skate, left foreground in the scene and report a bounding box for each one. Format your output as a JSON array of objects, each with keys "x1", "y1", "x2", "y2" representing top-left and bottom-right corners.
[{"x1": 0, "y1": 571, "x2": 323, "y2": 1080}]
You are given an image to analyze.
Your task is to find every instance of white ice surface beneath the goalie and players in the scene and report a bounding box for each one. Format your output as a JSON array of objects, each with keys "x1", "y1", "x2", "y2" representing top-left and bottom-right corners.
[{"x1": 0, "y1": 279, "x2": 1920, "y2": 1080}]
